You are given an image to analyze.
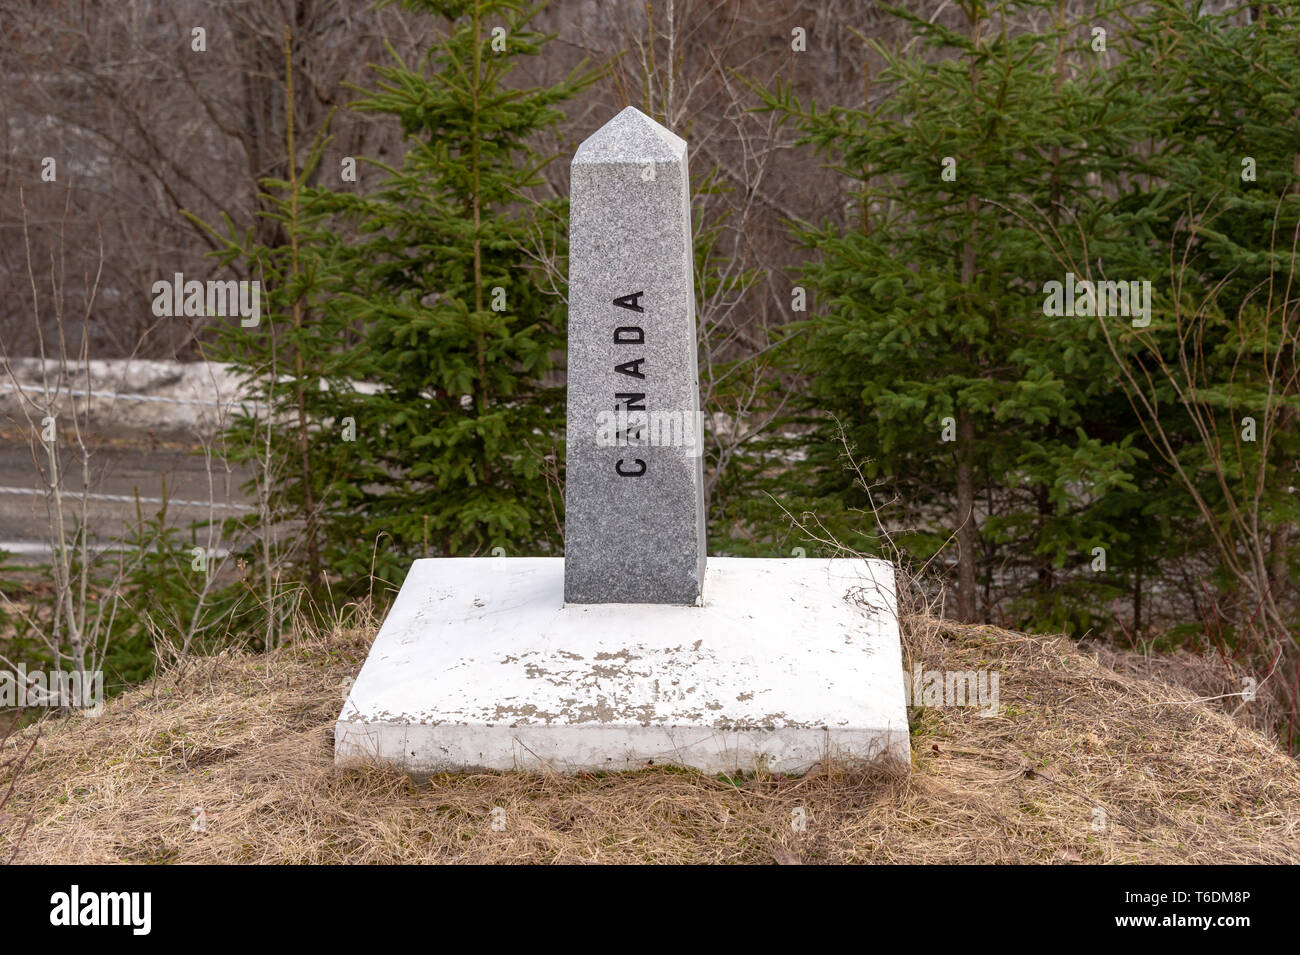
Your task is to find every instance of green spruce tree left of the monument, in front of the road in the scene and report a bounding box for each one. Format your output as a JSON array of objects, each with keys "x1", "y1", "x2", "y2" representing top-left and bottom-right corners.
[{"x1": 214, "y1": 0, "x2": 594, "y2": 590}]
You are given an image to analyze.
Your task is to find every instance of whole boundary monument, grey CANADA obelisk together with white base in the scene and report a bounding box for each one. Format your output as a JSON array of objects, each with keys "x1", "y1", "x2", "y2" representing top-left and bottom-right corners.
[{"x1": 334, "y1": 107, "x2": 910, "y2": 773}]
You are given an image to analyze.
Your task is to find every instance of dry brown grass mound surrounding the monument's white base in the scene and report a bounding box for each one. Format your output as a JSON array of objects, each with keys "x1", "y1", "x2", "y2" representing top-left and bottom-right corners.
[{"x1": 0, "y1": 618, "x2": 1300, "y2": 863}]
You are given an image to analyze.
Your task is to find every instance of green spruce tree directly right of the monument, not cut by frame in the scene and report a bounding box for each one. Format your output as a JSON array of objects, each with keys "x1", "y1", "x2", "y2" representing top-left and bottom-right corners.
[{"x1": 766, "y1": 0, "x2": 1141, "y2": 630}]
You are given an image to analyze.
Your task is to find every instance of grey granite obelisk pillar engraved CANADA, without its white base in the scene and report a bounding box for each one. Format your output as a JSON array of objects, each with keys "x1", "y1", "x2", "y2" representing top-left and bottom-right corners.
[{"x1": 564, "y1": 107, "x2": 706, "y2": 604}]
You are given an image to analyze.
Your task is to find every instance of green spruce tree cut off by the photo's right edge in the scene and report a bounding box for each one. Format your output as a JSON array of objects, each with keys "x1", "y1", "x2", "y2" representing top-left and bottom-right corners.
[{"x1": 1114, "y1": 0, "x2": 1300, "y2": 647}]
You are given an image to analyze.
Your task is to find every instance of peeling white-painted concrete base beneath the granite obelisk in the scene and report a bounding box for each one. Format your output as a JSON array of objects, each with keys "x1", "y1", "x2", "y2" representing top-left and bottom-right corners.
[{"x1": 334, "y1": 557, "x2": 910, "y2": 773}]
